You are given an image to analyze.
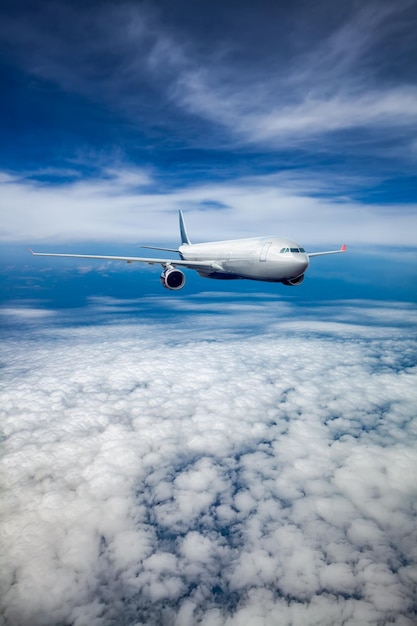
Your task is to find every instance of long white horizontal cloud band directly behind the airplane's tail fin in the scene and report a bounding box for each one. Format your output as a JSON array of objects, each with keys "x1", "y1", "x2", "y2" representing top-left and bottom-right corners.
[{"x1": 0, "y1": 168, "x2": 417, "y2": 245}]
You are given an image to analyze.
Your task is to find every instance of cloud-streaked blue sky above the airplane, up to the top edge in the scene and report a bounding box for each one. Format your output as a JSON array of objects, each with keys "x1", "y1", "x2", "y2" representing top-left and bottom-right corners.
[{"x1": 0, "y1": 1, "x2": 417, "y2": 300}]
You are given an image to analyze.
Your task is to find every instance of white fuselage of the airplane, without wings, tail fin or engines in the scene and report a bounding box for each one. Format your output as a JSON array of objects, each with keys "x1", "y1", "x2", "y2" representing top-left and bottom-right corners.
[{"x1": 178, "y1": 237, "x2": 310, "y2": 282}]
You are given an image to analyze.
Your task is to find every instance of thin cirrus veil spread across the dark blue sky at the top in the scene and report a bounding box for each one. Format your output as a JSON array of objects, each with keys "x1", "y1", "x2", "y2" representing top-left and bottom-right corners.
[{"x1": 2, "y1": 2, "x2": 417, "y2": 151}]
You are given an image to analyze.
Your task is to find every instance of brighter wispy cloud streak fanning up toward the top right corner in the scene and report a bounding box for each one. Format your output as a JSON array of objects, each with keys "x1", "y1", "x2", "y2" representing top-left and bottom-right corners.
[{"x1": 171, "y1": 3, "x2": 417, "y2": 147}]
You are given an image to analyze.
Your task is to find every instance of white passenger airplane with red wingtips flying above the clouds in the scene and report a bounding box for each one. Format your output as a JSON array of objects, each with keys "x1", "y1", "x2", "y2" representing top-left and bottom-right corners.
[{"x1": 29, "y1": 210, "x2": 346, "y2": 291}]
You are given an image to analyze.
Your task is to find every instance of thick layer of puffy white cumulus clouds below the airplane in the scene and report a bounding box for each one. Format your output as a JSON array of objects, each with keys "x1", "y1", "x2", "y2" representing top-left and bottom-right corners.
[{"x1": 1, "y1": 309, "x2": 417, "y2": 626}]
